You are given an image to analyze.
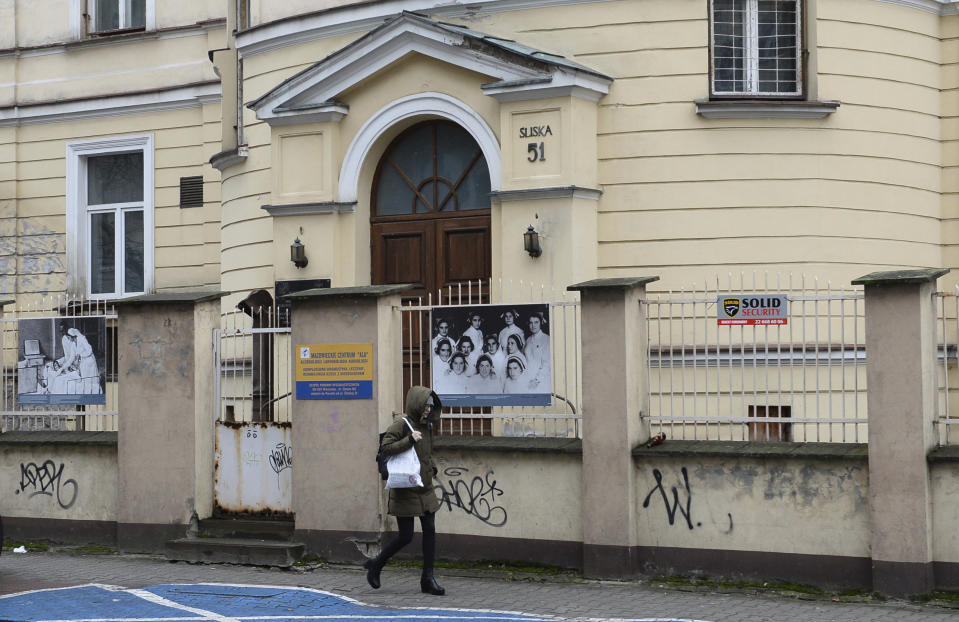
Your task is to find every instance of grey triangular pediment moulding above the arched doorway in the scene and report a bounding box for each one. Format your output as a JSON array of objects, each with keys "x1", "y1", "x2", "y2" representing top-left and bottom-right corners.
[{"x1": 248, "y1": 12, "x2": 612, "y2": 125}]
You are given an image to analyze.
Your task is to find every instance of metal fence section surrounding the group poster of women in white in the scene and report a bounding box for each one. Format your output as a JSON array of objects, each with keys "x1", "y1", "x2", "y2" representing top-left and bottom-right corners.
[{"x1": 395, "y1": 280, "x2": 582, "y2": 438}]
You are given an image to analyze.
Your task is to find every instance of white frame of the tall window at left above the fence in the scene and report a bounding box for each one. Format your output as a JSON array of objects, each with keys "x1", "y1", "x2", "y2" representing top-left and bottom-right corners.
[{"x1": 66, "y1": 134, "x2": 154, "y2": 300}]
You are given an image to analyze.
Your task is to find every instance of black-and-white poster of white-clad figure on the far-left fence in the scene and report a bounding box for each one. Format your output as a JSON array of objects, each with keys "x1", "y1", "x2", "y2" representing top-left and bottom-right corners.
[{"x1": 17, "y1": 317, "x2": 107, "y2": 405}]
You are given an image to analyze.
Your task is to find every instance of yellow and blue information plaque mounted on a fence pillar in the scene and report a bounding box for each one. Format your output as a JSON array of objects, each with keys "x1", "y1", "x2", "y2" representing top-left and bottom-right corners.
[{"x1": 296, "y1": 343, "x2": 373, "y2": 400}]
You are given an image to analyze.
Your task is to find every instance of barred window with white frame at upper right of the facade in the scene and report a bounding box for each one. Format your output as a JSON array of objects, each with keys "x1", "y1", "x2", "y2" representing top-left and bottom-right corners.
[{"x1": 710, "y1": 0, "x2": 802, "y2": 97}]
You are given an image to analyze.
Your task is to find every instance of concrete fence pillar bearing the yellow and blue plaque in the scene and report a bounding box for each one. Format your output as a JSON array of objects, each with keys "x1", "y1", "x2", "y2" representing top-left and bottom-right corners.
[{"x1": 286, "y1": 285, "x2": 409, "y2": 561}]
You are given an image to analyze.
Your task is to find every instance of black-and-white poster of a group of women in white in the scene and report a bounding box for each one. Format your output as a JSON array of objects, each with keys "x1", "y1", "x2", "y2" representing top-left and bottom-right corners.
[{"x1": 430, "y1": 304, "x2": 552, "y2": 406}]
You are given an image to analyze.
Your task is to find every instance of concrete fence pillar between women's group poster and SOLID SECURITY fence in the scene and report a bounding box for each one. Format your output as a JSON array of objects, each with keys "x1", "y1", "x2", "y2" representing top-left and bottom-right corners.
[{"x1": 568, "y1": 277, "x2": 659, "y2": 578}]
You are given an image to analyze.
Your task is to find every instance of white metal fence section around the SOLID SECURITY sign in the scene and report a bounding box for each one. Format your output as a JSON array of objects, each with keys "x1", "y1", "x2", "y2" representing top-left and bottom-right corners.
[{"x1": 643, "y1": 274, "x2": 867, "y2": 442}]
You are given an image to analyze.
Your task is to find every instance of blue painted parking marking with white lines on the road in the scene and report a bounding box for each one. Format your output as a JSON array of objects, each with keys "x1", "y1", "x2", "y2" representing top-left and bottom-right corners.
[{"x1": 0, "y1": 583, "x2": 696, "y2": 622}]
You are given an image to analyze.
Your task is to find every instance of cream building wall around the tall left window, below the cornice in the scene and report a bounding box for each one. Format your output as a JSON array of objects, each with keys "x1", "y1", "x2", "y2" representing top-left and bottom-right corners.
[{"x1": 0, "y1": 103, "x2": 220, "y2": 300}]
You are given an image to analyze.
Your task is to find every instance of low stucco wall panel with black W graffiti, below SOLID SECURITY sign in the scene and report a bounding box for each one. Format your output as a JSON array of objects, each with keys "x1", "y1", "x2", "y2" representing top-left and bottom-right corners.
[{"x1": 636, "y1": 454, "x2": 871, "y2": 558}]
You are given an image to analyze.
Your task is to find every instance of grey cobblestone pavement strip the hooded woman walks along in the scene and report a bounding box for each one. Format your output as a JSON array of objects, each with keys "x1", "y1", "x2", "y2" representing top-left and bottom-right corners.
[{"x1": 0, "y1": 551, "x2": 959, "y2": 622}]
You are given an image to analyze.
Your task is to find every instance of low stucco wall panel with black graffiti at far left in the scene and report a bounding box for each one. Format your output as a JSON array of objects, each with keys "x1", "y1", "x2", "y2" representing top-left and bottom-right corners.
[{"x1": 0, "y1": 435, "x2": 117, "y2": 528}]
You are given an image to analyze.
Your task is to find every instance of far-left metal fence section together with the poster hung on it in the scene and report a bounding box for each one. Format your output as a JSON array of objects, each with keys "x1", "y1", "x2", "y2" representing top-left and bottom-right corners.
[{"x1": 0, "y1": 295, "x2": 118, "y2": 432}]
